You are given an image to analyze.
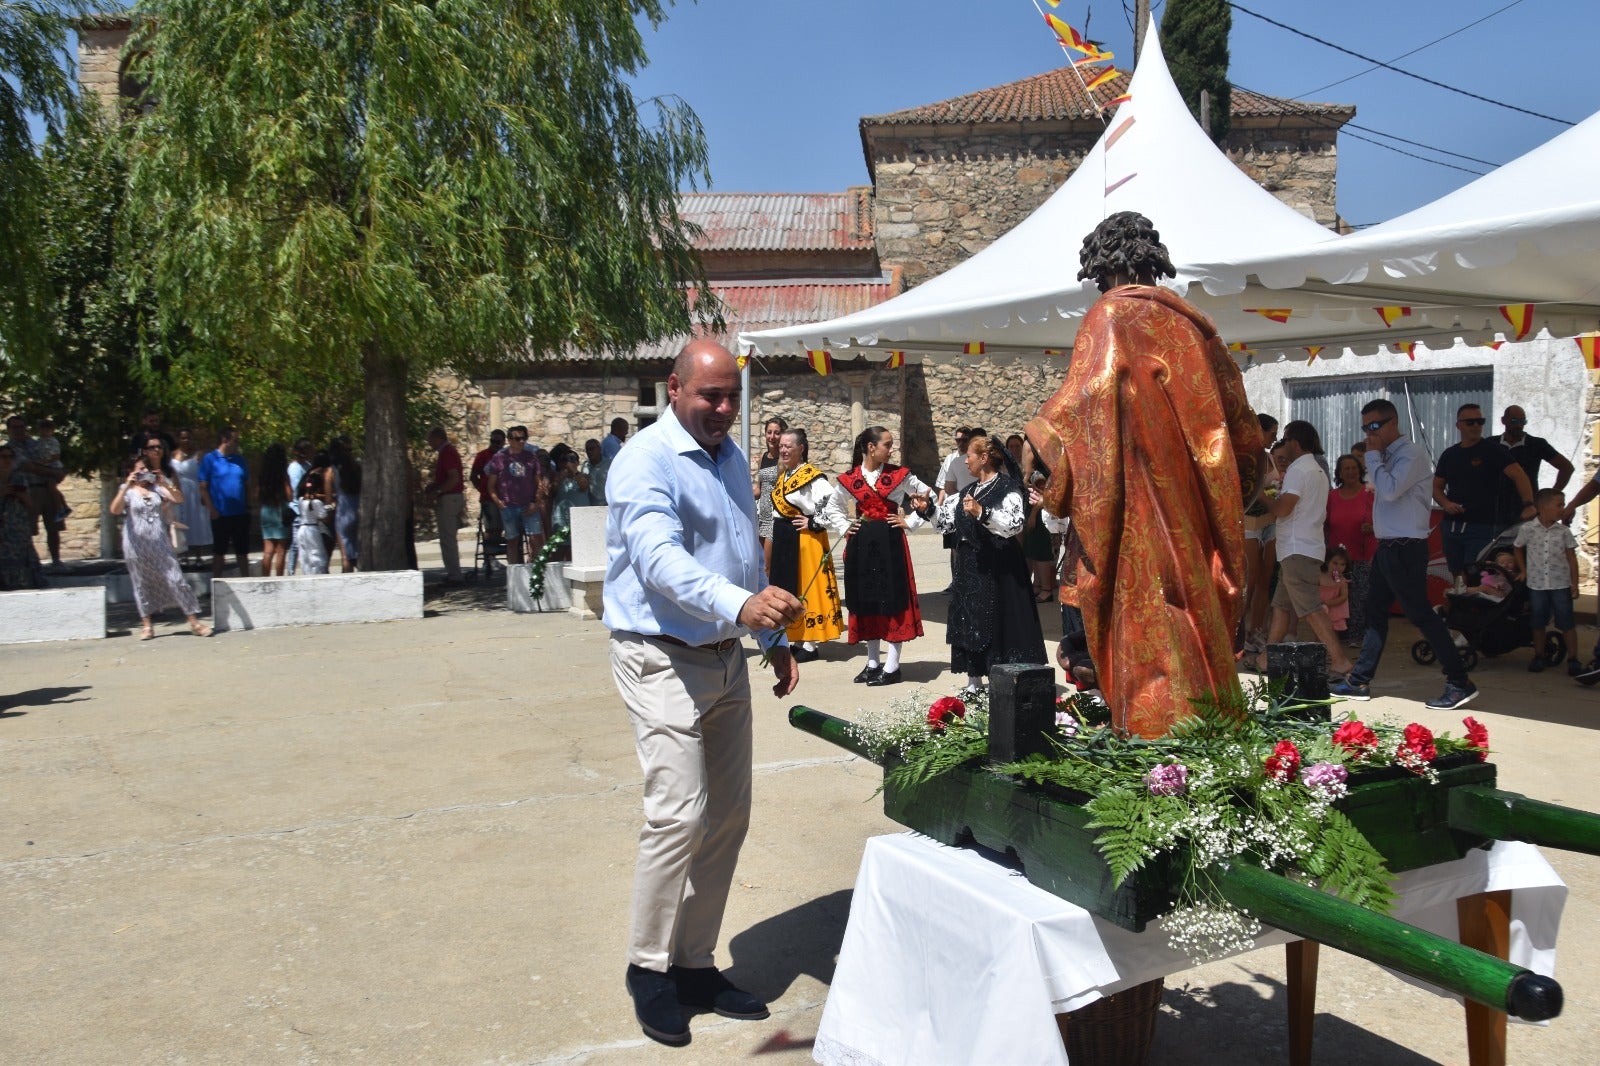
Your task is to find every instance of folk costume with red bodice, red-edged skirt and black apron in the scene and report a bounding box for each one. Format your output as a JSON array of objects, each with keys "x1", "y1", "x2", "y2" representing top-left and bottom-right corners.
[{"x1": 834, "y1": 463, "x2": 931, "y2": 653}]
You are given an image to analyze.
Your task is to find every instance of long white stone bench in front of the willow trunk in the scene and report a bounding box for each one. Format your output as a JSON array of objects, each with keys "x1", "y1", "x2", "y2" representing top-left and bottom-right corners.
[{"x1": 211, "y1": 570, "x2": 422, "y2": 631}]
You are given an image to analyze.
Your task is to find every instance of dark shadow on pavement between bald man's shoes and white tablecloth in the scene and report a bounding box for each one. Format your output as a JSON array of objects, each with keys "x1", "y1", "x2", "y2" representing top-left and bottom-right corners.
[{"x1": 726, "y1": 888, "x2": 853, "y2": 1004}]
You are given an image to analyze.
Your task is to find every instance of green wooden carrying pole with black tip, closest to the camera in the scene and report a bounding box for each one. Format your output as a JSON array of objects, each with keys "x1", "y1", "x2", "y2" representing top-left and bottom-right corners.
[{"x1": 1216, "y1": 863, "x2": 1562, "y2": 1021}]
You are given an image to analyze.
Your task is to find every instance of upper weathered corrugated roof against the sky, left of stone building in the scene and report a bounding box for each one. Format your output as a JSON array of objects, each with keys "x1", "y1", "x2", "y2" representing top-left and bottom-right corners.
[{"x1": 678, "y1": 187, "x2": 874, "y2": 251}]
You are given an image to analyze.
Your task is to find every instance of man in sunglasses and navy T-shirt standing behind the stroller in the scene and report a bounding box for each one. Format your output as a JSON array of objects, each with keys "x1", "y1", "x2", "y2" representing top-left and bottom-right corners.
[{"x1": 1434, "y1": 403, "x2": 1534, "y2": 587}]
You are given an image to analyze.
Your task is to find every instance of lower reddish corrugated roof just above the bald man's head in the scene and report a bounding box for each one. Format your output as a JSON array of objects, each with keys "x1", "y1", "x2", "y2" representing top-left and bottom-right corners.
[{"x1": 620, "y1": 267, "x2": 902, "y2": 359}]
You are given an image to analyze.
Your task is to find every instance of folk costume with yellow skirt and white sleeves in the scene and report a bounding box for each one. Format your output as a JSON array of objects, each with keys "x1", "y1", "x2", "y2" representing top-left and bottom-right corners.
[{"x1": 766, "y1": 463, "x2": 845, "y2": 651}]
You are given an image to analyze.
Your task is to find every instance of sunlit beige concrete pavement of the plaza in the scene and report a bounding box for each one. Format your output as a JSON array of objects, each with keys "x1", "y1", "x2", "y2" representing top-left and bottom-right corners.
[{"x1": 0, "y1": 533, "x2": 1600, "y2": 1066}]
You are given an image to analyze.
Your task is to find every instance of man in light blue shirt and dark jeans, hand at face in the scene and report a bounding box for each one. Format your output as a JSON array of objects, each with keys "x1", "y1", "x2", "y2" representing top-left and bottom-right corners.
[{"x1": 1331, "y1": 400, "x2": 1472, "y2": 711}]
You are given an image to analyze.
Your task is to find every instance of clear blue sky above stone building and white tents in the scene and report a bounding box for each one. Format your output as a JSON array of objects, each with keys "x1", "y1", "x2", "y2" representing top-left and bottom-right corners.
[{"x1": 637, "y1": 0, "x2": 1600, "y2": 224}]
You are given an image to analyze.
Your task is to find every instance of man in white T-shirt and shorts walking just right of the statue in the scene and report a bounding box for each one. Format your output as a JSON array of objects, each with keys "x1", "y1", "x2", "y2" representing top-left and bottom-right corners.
[{"x1": 1262, "y1": 421, "x2": 1355, "y2": 677}]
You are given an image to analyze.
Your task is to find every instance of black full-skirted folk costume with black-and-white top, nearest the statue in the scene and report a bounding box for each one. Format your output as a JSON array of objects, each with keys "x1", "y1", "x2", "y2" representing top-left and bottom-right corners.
[{"x1": 934, "y1": 472, "x2": 1050, "y2": 690}]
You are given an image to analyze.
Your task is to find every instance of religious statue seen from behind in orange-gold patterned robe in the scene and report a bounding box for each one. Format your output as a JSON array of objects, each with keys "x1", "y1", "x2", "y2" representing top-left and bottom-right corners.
[{"x1": 1027, "y1": 211, "x2": 1266, "y2": 738}]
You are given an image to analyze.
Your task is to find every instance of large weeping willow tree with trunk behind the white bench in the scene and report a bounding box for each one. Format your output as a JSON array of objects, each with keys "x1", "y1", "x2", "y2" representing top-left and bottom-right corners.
[{"x1": 128, "y1": 0, "x2": 715, "y2": 570}]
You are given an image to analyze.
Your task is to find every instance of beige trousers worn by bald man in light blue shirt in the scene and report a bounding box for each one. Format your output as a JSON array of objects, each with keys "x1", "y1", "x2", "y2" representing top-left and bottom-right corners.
[{"x1": 611, "y1": 632, "x2": 750, "y2": 970}]
